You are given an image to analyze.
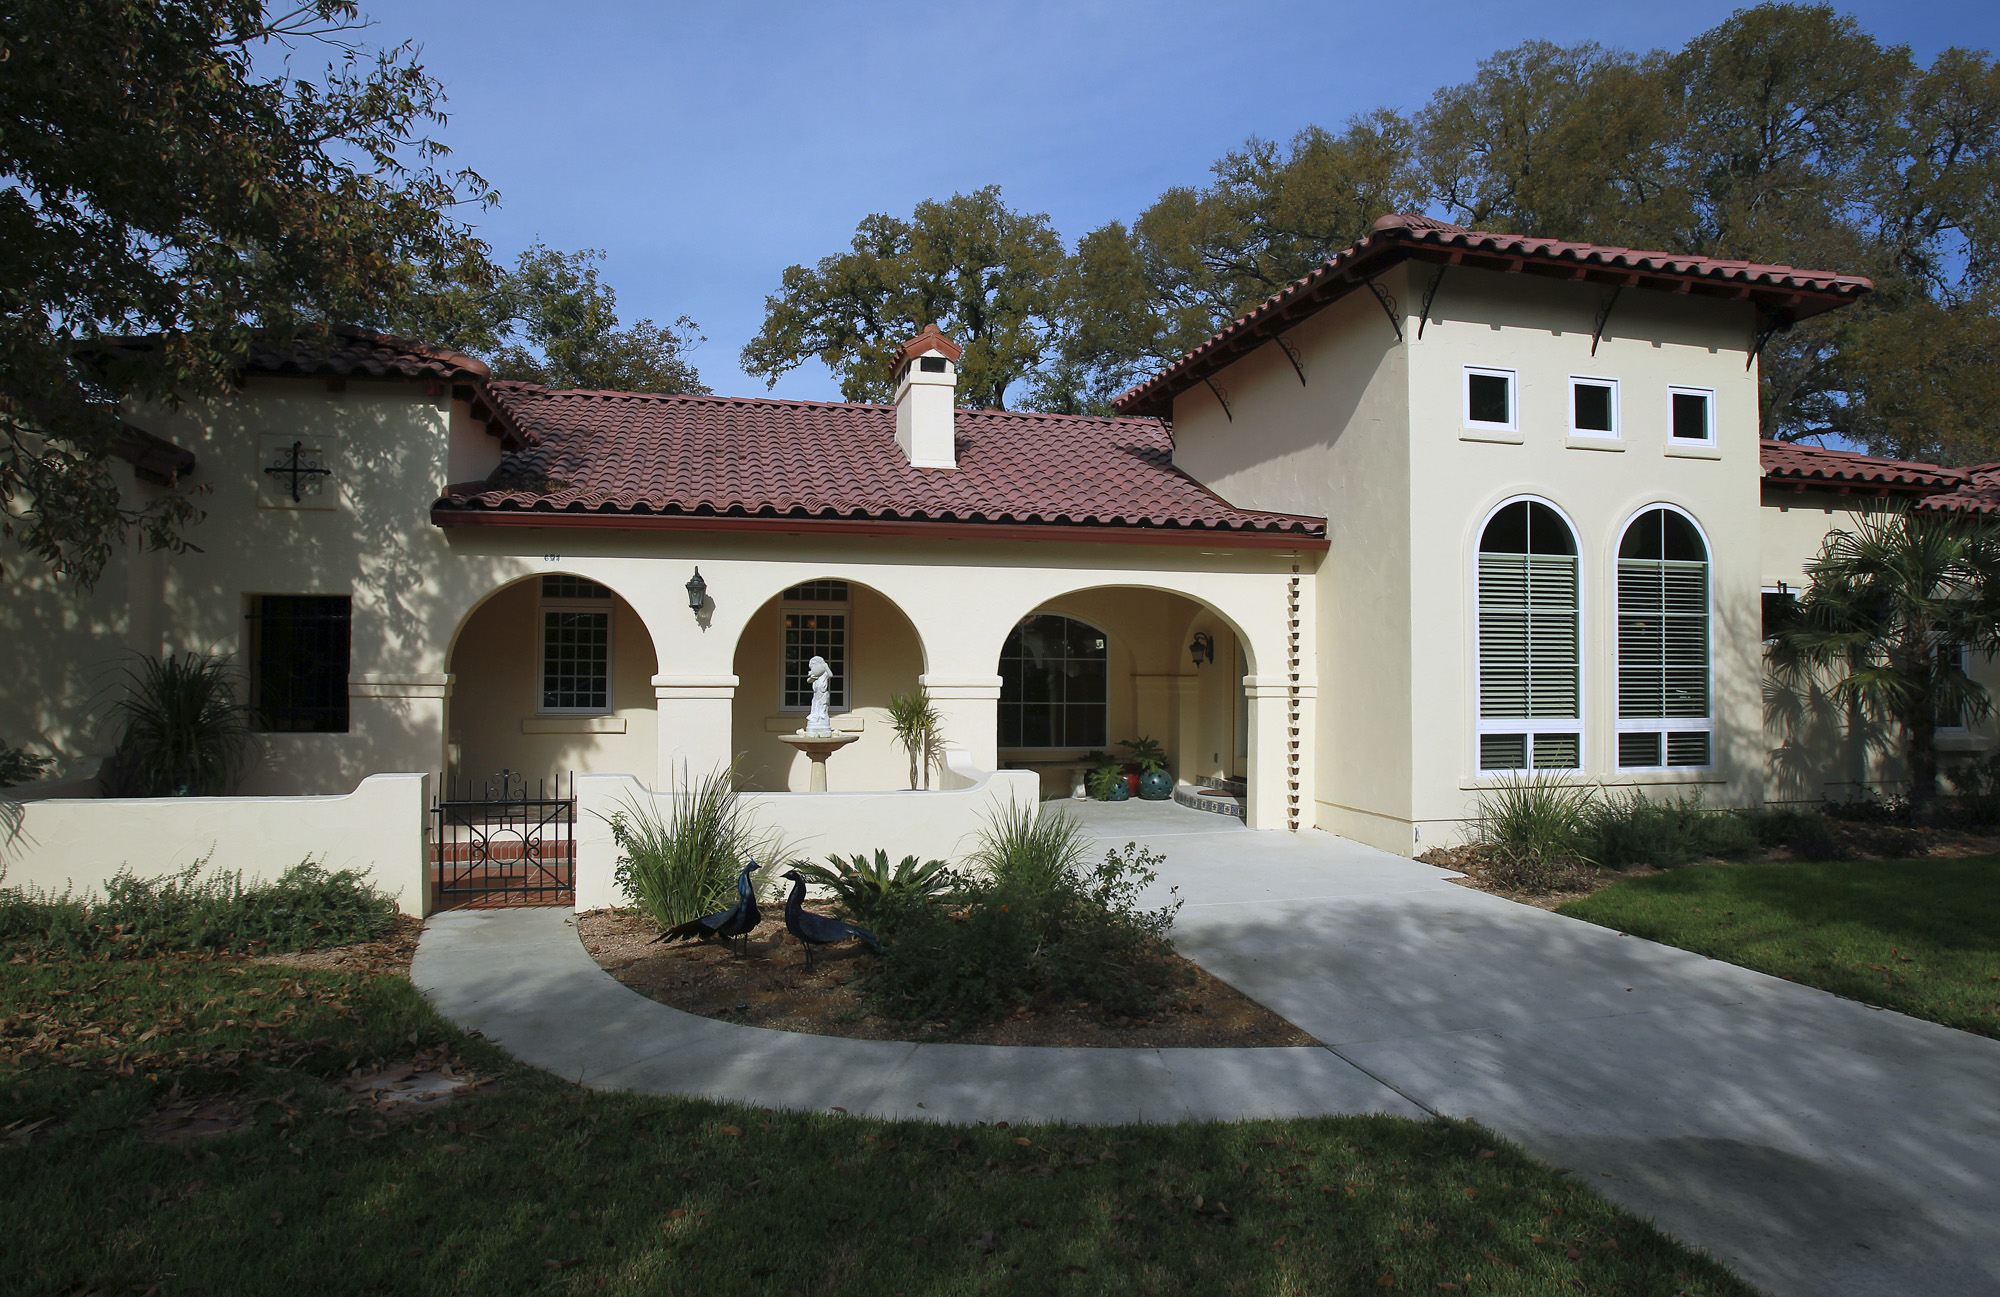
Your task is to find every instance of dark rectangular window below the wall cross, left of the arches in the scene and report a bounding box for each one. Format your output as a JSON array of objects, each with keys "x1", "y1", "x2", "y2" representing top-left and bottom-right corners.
[{"x1": 250, "y1": 594, "x2": 354, "y2": 735}]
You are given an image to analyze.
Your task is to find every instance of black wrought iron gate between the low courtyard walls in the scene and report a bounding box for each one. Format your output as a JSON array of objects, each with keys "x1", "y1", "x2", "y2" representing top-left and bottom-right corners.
[{"x1": 430, "y1": 771, "x2": 576, "y2": 909}]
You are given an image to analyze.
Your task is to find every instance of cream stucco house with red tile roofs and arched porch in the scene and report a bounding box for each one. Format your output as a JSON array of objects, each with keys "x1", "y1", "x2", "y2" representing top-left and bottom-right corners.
[{"x1": 0, "y1": 216, "x2": 1944, "y2": 892}]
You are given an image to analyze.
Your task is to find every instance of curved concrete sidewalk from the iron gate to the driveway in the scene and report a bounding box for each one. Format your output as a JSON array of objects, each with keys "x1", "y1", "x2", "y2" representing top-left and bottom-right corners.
[{"x1": 410, "y1": 909, "x2": 1428, "y2": 1125}]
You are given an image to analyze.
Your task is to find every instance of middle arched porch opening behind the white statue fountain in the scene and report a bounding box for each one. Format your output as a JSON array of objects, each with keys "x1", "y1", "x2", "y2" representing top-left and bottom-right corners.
[{"x1": 730, "y1": 576, "x2": 924, "y2": 793}]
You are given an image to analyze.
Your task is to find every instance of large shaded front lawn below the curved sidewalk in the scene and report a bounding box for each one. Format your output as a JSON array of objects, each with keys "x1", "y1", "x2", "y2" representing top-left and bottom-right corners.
[{"x1": 0, "y1": 953, "x2": 1752, "y2": 1297}]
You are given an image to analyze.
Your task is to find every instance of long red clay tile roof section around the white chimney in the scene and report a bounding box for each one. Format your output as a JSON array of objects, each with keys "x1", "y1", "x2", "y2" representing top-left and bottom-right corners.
[{"x1": 432, "y1": 382, "x2": 1326, "y2": 548}]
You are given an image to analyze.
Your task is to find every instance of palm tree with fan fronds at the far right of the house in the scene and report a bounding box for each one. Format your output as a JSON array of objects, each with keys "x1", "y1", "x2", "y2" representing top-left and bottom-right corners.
[{"x1": 1772, "y1": 506, "x2": 2000, "y2": 821}]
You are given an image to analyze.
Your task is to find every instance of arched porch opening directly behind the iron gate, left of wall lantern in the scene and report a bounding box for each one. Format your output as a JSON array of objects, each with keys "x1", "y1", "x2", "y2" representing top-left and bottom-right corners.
[{"x1": 446, "y1": 572, "x2": 660, "y2": 789}]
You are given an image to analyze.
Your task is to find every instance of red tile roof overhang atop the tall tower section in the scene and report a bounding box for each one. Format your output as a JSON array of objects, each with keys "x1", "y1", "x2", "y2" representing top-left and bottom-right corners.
[{"x1": 1112, "y1": 214, "x2": 1874, "y2": 418}]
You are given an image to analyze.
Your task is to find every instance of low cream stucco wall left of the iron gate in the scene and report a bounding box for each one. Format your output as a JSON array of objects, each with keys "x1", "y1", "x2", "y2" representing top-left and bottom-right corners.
[{"x1": 0, "y1": 775, "x2": 430, "y2": 915}]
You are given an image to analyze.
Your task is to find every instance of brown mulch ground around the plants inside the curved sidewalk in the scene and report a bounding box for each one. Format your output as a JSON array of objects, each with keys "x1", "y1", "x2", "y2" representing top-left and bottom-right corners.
[{"x1": 576, "y1": 911, "x2": 1318, "y2": 1049}]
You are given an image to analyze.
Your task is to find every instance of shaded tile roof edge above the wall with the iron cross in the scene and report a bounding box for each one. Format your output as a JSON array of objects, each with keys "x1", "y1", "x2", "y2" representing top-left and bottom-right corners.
[{"x1": 82, "y1": 324, "x2": 530, "y2": 450}]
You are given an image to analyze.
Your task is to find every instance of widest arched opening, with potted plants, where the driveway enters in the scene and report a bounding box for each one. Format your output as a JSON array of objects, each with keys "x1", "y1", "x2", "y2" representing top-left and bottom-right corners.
[{"x1": 996, "y1": 586, "x2": 1254, "y2": 815}]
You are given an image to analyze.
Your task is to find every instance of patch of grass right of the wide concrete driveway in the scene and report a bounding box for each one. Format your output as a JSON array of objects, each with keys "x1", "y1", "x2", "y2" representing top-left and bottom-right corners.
[{"x1": 1560, "y1": 857, "x2": 2000, "y2": 1037}]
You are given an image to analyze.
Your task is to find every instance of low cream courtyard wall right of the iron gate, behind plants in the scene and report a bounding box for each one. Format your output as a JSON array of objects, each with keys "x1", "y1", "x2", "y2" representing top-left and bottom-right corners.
[{"x1": 576, "y1": 753, "x2": 1042, "y2": 911}]
